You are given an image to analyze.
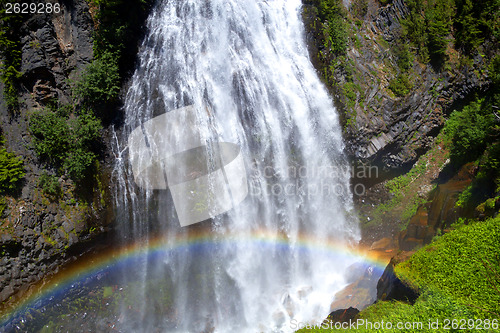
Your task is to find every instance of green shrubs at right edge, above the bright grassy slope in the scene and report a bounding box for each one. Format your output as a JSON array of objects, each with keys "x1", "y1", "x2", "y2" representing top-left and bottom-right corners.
[{"x1": 444, "y1": 55, "x2": 500, "y2": 211}]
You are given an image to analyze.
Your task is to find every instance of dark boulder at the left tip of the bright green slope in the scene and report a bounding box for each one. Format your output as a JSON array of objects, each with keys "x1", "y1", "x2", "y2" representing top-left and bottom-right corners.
[{"x1": 377, "y1": 252, "x2": 418, "y2": 303}]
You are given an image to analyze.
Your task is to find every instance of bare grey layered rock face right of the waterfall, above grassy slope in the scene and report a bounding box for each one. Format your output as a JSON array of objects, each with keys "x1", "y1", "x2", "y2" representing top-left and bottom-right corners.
[{"x1": 304, "y1": 0, "x2": 488, "y2": 179}]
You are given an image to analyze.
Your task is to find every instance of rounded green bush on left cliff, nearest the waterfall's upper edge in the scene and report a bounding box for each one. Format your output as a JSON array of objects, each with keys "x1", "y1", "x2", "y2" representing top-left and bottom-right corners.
[{"x1": 74, "y1": 51, "x2": 120, "y2": 106}]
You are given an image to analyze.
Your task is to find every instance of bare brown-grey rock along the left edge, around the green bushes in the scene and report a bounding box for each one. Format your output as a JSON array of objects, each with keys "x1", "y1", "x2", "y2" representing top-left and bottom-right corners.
[{"x1": 0, "y1": 0, "x2": 110, "y2": 306}]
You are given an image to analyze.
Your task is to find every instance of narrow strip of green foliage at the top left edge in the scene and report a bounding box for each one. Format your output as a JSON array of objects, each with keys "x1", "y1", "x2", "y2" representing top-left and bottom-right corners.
[{"x1": 0, "y1": 0, "x2": 22, "y2": 109}]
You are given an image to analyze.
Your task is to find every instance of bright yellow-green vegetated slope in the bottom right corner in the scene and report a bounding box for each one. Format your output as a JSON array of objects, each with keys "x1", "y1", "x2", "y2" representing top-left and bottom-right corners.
[{"x1": 299, "y1": 218, "x2": 500, "y2": 332}]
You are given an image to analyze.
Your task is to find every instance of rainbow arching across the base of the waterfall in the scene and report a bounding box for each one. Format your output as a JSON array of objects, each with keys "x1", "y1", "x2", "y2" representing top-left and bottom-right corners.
[{"x1": 0, "y1": 228, "x2": 389, "y2": 328}]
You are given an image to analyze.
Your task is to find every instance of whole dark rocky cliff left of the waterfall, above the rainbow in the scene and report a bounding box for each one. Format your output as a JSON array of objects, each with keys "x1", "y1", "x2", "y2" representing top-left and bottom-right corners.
[{"x1": 0, "y1": 0, "x2": 152, "y2": 308}]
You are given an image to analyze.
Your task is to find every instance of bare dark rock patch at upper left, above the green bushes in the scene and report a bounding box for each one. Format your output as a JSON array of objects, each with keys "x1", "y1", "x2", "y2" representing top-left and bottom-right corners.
[{"x1": 21, "y1": 1, "x2": 93, "y2": 107}]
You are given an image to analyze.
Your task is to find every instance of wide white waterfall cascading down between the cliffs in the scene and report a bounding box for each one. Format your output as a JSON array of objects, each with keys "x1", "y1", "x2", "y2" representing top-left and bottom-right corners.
[{"x1": 115, "y1": 0, "x2": 358, "y2": 332}]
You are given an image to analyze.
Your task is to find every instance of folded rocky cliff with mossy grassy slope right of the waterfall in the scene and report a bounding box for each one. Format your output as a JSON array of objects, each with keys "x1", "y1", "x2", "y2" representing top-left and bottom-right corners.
[{"x1": 303, "y1": 0, "x2": 498, "y2": 244}]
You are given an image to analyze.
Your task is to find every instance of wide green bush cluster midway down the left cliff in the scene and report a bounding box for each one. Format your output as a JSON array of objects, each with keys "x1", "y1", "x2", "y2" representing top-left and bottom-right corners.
[{"x1": 30, "y1": 110, "x2": 102, "y2": 181}]
